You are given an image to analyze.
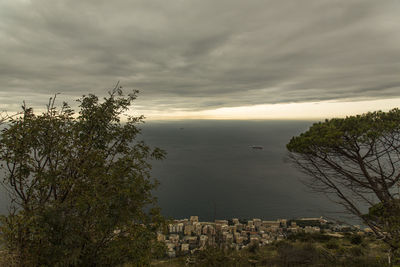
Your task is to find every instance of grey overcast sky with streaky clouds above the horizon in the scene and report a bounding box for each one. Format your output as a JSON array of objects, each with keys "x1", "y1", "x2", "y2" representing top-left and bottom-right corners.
[{"x1": 0, "y1": 0, "x2": 400, "y2": 118}]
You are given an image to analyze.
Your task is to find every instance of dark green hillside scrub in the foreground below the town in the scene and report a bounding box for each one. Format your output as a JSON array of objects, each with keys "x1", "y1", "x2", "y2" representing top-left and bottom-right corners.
[{"x1": 154, "y1": 234, "x2": 388, "y2": 267}]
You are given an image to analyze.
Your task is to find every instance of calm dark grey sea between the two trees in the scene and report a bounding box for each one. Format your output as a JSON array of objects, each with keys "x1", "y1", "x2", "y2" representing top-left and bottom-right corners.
[{"x1": 142, "y1": 120, "x2": 337, "y2": 221}]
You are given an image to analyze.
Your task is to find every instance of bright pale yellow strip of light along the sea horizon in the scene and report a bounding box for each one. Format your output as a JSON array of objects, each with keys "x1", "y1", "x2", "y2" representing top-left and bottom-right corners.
[{"x1": 135, "y1": 98, "x2": 400, "y2": 120}]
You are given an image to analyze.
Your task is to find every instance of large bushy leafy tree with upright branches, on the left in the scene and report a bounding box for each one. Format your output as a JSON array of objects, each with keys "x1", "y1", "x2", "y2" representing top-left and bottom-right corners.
[{"x1": 0, "y1": 86, "x2": 165, "y2": 266}]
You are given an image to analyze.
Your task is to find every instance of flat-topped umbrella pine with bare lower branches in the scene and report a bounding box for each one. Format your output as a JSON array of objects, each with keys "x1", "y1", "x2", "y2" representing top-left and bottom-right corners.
[{"x1": 287, "y1": 109, "x2": 400, "y2": 260}]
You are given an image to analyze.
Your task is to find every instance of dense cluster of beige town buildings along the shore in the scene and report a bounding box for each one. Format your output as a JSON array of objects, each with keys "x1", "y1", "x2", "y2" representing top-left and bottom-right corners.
[{"x1": 157, "y1": 216, "x2": 372, "y2": 257}]
